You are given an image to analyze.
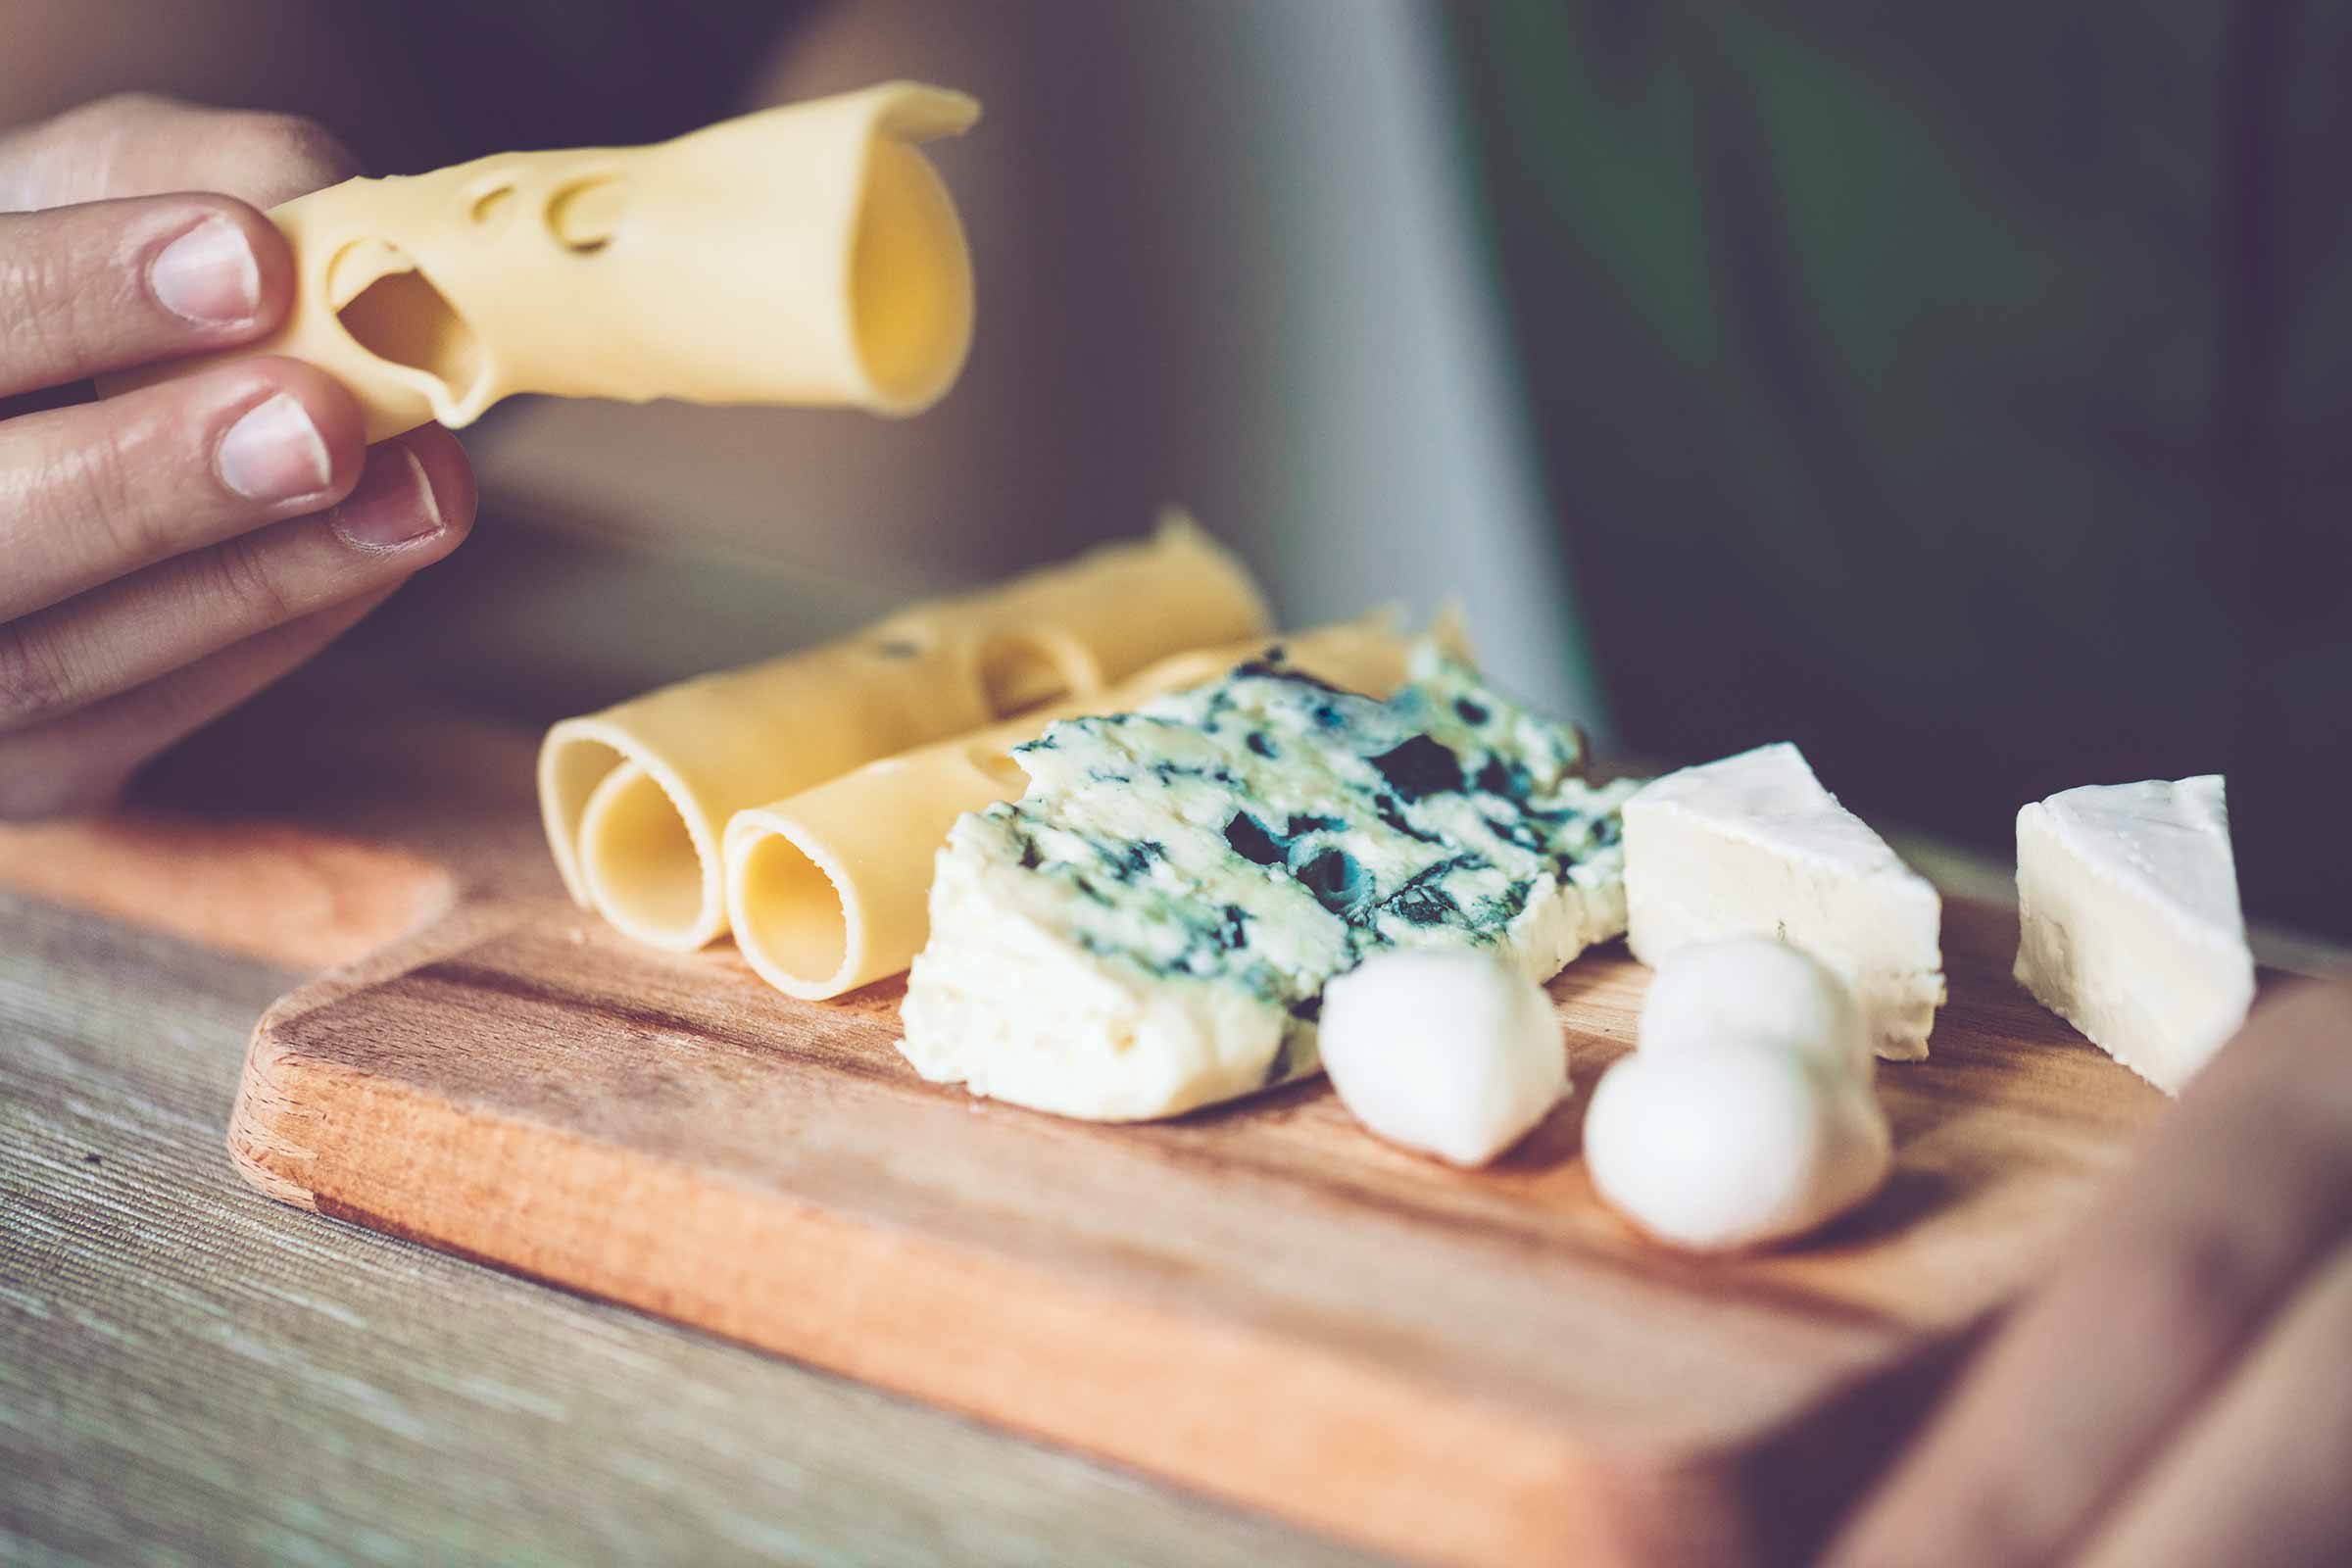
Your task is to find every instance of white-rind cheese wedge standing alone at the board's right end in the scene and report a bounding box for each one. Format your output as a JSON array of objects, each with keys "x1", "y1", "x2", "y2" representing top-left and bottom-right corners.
[{"x1": 2013, "y1": 773, "x2": 2253, "y2": 1093}]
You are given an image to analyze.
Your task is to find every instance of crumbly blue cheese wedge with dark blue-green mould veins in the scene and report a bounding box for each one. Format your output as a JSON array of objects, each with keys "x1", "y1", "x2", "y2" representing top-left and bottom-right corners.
[{"x1": 901, "y1": 651, "x2": 1635, "y2": 1121}]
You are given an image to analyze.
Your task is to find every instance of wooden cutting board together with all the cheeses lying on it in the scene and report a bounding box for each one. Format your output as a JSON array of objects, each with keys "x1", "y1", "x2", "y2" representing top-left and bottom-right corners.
[{"x1": 178, "y1": 512, "x2": 2253, "y2": 1561}]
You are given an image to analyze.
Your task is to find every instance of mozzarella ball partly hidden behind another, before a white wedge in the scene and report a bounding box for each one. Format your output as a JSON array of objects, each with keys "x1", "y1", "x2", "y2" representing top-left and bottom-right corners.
[{"x1": 1642, "y1": 936, "x2": 1872, "y2": 1081}]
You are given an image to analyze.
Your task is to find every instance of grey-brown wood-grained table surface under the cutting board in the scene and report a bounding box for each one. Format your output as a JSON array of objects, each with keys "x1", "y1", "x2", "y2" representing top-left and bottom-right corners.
[{"x1": 0, "y1": 686, "x2": 2340, "y2": 1563}]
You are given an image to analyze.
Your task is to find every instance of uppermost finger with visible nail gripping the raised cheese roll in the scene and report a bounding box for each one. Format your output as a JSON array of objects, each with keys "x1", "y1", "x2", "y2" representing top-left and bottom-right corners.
[{"x1": 0, "y1": 195, "x2": 294, "y2": 397}]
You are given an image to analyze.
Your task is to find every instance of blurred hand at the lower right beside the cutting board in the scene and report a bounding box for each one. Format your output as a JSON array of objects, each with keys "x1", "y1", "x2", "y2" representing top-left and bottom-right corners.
[{"x1": 1825, "y1": 983, "x2": 2352, "y2": 1568}]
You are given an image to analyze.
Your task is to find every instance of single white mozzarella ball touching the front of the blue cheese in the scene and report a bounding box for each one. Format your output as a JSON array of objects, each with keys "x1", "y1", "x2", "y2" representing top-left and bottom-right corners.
[{"x1": 1322, "y1": 953, "x2": 1569, "y2": 1166}]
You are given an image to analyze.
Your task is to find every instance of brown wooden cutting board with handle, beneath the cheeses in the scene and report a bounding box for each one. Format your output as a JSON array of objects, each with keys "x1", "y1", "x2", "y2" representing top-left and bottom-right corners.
[{"x1": 0, "y1": 714, "x2": 2164, "y2": 1563}]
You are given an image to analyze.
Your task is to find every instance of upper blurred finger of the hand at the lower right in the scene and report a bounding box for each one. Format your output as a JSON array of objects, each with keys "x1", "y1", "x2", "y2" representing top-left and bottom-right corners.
[{"x1": 1830, "y1": 985, "x2": 2352, "y2": 1566}]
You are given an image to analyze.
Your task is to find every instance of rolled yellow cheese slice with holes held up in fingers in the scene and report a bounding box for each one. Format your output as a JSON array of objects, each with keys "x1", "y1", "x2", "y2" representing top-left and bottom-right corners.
[{"x1": 99, "y1": 82, "x2": 981, "y2": 442}]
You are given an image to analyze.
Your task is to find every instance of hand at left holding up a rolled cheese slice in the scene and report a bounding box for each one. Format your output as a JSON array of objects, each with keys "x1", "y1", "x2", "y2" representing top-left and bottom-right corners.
[{"x1": 0, "y1": 96, "x2": 475, "y2": 818}]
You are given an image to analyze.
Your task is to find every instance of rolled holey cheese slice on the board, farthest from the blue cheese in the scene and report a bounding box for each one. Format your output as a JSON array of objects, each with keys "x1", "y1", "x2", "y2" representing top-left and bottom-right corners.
[{"x1": 539, "y1": 517, "x2": 1268, "y2": 953}]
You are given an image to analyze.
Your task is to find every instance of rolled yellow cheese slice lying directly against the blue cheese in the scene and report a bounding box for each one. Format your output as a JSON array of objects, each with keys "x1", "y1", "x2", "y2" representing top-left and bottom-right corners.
[{"x1": 724, "y1": 612, "x2": 1460, "y2": 1002}]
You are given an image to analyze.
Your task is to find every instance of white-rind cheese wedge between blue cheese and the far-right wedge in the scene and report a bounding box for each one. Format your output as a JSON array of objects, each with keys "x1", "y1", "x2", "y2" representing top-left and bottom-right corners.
[{"x1": 1625, "y1": 743, "x2": 1942, "y2": 1060}]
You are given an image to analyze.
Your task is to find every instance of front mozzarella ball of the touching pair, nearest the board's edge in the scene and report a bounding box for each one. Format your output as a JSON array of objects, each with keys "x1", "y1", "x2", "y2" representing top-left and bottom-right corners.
[{"x1": 1586, "y1": 1042, "x2": 1891, "y2": 1250}]
